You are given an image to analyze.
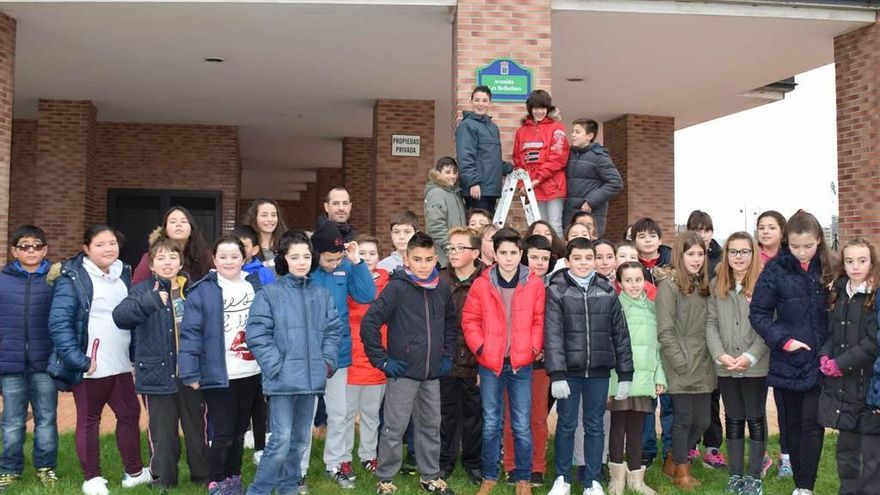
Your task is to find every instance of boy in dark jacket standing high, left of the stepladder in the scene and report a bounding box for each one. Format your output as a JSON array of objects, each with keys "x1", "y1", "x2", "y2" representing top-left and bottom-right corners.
[{"x1": 455, "y1": 86, "x2": 513, "y2": 214}]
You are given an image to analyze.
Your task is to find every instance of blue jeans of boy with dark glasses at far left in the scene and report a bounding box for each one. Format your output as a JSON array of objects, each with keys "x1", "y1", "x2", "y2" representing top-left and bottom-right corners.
[{"x1": 0, "y1": 373, "x2": 58, "y2": 474}]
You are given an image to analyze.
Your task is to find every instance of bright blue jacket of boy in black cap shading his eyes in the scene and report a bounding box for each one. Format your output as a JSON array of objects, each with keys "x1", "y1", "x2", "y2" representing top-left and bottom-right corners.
[{"x1": 309, "y1": 258, "x2": 376, "y2": 368}]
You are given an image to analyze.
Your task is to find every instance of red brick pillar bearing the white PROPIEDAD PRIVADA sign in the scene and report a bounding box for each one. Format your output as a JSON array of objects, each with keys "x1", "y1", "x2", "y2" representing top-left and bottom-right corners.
[{"x1": 370, "y1": 100, "x2": 434, "y2": 239}]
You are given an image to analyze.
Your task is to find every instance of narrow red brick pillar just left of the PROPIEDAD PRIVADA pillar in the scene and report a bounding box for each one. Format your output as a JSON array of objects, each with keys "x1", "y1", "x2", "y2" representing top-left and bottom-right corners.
[{"x1": 342, "y1": 137, "x2": 375, "y2": 235}]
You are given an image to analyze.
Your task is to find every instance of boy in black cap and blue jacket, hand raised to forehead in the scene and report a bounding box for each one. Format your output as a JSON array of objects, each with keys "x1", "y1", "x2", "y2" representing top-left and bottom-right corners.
[{"x1": 302, "y1": 222, "x2": 376, "y2": 488}]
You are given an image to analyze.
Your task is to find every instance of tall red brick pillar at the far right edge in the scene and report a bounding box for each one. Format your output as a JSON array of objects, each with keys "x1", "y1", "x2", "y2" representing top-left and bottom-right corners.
[{"x1": 828, "y1": 23, "x2": 880, "y2": 244}]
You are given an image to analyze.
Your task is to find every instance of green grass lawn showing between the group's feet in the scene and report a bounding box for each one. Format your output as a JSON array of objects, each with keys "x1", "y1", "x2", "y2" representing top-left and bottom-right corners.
[{"x1": 4, "y1": 433, "x2": 838, "y2": 495}]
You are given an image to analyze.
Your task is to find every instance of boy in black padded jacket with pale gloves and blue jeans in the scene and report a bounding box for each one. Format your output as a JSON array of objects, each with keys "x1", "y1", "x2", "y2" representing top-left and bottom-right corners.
[{"x1": 544, "y1": 238, "x2": 634, "y2": 495}]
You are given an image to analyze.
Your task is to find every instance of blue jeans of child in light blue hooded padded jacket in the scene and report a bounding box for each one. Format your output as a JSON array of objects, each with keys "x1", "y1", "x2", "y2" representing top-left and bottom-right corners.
[{"x1": 247, "y1": 395, "x2": 316, "y2": 495}]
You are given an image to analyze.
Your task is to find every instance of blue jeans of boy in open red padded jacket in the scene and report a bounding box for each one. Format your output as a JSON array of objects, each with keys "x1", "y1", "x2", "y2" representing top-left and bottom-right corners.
[{"x1": 480, "y1": 363, "x2": 528, "y2": 481}]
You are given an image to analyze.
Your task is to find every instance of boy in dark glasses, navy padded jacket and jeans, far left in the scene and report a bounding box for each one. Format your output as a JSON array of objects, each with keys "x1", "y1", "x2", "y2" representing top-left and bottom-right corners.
[{"x1": 0, "y1": 225, "x2": 58, "y2": 491}]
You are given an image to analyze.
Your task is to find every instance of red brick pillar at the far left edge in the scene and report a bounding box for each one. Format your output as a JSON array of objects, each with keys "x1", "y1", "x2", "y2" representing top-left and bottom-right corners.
[{"x1": 0, "y1": 12, "x2": 15, "y2": 263}]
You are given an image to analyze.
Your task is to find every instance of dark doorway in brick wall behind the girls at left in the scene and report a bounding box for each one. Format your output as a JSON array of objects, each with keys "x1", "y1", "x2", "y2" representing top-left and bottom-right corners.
[{"x1": 107, "y1": 189, "x2": 223, "y2": 268}]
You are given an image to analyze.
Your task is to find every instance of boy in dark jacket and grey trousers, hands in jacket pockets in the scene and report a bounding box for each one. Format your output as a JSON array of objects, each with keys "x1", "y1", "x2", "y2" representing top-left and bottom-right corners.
[{"x1": 361, "y1": 232, "x2": 458, "y2": 495}]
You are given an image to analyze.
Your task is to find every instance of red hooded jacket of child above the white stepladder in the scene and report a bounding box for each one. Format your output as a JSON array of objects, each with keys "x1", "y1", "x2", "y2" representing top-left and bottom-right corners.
[{"x1": 513, "y1": 115, "x2": 569, "y2": 201}]
